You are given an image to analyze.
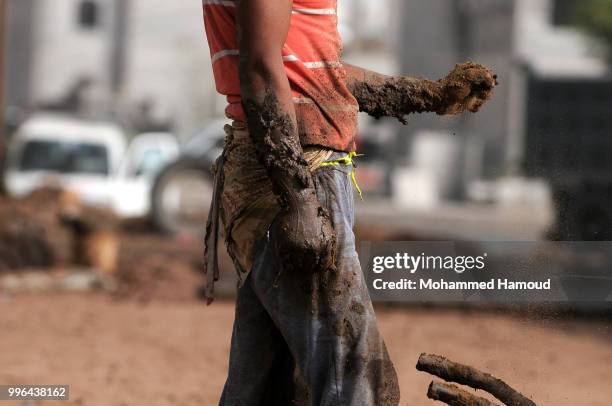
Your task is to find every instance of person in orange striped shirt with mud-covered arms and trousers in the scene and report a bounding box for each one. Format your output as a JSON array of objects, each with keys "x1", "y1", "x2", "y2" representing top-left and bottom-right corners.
[{"x1": 204, "y1": 0, "x2": 496, "y2": 406}]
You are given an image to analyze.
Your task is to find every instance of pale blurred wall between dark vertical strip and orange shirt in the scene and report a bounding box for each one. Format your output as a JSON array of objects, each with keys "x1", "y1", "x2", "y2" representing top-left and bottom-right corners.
[{"x1": 123, "y1": 0, "x2": 225, "y2": 134}]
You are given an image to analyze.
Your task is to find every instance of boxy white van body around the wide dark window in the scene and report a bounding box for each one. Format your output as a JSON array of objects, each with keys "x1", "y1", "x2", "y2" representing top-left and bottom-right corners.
[{"x1": 5, "y1": 115, "x2": 126, "y2": 207}]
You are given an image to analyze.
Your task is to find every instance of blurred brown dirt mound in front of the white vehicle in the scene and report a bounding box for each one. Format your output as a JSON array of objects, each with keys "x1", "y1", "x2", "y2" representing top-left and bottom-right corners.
[{"x1": 0, "y1": 188, "x2": 208, "y2": 301}]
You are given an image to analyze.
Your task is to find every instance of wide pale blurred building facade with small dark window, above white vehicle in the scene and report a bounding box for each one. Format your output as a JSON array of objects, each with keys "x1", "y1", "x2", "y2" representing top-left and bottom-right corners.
[{"x1": 7, "y1": 0, "x2": 225, "y2": 134}]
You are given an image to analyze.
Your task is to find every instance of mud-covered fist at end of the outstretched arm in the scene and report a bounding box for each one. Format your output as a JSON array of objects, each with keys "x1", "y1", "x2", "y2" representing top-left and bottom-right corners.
[{"x1": 436, "y1": 62, "x2": 498, "y2": 115}]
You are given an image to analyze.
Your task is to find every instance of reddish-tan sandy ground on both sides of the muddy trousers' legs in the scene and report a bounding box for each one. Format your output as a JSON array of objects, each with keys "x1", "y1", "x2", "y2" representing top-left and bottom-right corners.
[{"x1": 0, "y1": 295, "x2": 612, "y2": 406}]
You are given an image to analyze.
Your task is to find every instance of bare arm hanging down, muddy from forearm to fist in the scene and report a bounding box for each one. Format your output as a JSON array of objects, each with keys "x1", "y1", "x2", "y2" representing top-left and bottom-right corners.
[{"x1": 236, "y1": 0, "x2": 336, "y2": 270}]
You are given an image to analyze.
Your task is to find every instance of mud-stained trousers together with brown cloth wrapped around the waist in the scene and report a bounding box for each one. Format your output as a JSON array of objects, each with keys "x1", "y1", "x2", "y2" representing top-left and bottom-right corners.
[{"x1": 220, "y1": 125, "x2": 399, "y2": 406}]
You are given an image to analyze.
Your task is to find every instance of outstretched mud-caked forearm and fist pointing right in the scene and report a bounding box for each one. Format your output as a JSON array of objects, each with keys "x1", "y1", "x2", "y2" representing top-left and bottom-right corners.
[{"x1": 344, "y1": 62, "x2": 497, "y2": 122}]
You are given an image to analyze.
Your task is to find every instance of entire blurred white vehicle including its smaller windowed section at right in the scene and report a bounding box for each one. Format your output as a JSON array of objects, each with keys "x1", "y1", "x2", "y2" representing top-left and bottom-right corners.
[{"x1": 4, "y1": 114, "x2": 178, "y2": 217}]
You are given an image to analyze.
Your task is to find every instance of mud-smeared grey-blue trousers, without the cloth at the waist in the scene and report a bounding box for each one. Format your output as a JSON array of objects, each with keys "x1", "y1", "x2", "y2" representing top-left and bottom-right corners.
[{"x1": 220, "y1": 163, "x2": 399, "y2": 406}]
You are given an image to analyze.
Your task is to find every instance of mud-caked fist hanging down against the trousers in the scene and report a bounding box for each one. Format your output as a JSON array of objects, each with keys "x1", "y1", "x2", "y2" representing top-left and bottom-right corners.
[{"x1": 270, "y1": 192, "x2": 336, "y2": 272}]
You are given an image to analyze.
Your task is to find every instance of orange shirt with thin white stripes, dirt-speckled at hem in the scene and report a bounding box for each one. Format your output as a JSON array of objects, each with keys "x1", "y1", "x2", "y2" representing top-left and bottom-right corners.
[{"x1": 203, "y1": 0, "x2": 359, "y2": 151}]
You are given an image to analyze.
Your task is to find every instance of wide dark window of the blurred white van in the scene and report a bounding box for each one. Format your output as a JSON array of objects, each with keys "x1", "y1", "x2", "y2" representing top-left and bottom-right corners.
[{"x1": 19, "y1": 140, "x2": 109, "y2": 175}]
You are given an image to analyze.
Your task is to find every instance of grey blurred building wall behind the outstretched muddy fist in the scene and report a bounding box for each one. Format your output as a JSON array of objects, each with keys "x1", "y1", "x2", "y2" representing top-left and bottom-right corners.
[{"x1": 398, "y1": 0, "x2": 514, "y2": 178}]
